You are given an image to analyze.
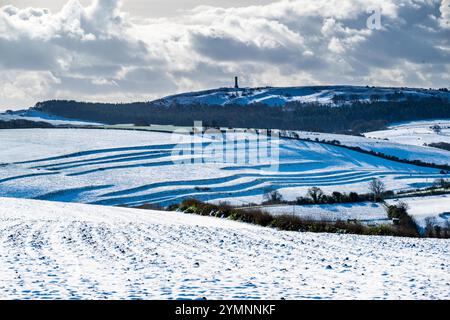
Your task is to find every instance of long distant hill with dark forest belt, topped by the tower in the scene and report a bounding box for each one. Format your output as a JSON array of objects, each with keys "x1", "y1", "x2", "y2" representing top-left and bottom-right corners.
[{"x1": 0, "y1": 86, "x2": 450, "y2": 134}]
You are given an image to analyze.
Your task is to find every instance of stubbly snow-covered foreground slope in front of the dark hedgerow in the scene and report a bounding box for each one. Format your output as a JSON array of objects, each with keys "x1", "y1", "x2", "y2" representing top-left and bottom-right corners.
[{"x1": 0, "y1": 198, "x2": 450, "y2": 299}]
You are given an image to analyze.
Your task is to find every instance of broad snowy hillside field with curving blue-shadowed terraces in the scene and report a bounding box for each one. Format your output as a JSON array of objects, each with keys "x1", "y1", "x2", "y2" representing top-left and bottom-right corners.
[{"x1": 0, "y1": 129, "x2": 450, "y2": 205}]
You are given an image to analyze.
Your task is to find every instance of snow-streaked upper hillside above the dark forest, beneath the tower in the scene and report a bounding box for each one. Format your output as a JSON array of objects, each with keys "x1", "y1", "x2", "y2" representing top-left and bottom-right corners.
[{"x1": 156, "y1": 86, "x2": 450, "y2": 106}]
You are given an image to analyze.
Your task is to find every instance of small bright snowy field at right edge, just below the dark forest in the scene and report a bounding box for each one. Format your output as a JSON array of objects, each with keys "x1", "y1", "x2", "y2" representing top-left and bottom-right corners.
[{"x1": 364, "y1": 120, "x2": 450, "y2": 146}]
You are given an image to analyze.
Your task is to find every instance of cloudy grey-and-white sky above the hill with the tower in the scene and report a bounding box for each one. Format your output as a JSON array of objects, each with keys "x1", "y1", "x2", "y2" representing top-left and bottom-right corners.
[{"x1": 0, "y1": 0, "x2": 450, "y2": 109}]
